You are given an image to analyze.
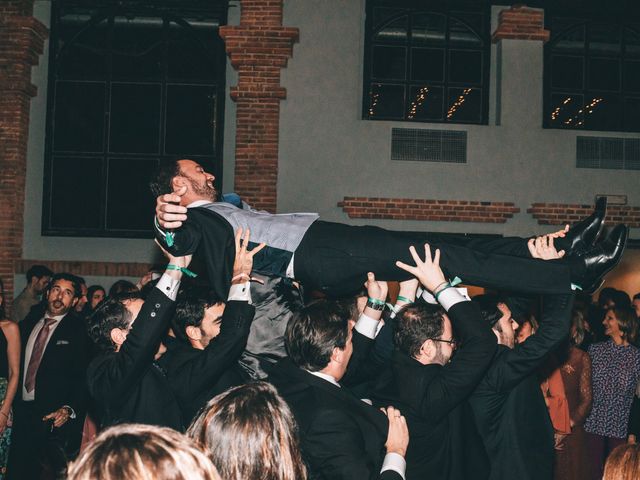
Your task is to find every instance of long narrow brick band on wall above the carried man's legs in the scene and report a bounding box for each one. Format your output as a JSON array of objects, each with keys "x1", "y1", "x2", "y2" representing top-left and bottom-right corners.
[{"x1": 338, "y1": 197, "x2": 520, "y2": 223}]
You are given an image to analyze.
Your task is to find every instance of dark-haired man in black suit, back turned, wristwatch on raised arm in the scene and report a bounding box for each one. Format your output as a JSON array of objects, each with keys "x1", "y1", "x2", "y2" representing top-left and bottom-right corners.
[{"x1": 269, "y1": 276, "x2": 408, "y2": 480}]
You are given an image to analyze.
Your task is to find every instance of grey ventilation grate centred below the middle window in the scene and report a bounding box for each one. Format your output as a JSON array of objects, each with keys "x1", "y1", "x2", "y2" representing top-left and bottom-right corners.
[{"x1": 391, "y1": 128, "x2": 467, "y2": 163}]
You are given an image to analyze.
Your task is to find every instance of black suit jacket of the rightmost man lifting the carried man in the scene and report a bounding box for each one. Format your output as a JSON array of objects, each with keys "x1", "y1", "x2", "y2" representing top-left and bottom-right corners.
[{"x1": 469, "y1": 295, "x2": 573, "y2": 480}]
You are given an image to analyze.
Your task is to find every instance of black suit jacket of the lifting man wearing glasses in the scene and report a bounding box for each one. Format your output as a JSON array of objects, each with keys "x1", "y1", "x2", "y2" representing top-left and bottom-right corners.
[{"x1": 373, "y1": 301, "x2": 496, "y2": 480}]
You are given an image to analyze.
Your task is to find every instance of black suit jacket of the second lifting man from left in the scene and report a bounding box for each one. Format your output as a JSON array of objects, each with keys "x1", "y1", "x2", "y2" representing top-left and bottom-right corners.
[{"x1": 158, "y1": 301, "x2": 255, "y2": 425}]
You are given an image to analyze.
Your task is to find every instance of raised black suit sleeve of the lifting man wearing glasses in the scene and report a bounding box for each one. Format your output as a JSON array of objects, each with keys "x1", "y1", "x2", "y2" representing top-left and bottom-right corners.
[{"x1": 420, "y1": 301, "x2": 497, "y2": 419}]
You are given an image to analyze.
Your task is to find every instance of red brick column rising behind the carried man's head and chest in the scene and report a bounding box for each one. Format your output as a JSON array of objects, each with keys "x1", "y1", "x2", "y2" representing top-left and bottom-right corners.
[{"x1": 220, "y1": 0, "x2": 298, "y2": 212}]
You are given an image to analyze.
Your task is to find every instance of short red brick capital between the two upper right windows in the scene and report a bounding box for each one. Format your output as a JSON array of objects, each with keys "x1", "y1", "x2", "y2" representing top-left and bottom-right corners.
[{"x1": 492, "y1": 5, "x2": 550, "y2": 43}]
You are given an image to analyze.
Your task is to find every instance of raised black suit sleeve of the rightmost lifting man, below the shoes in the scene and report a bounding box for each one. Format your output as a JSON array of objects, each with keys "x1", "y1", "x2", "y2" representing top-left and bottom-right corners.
[{"x1": 492, "y1": 295, "x2": 573, "y2": 391}]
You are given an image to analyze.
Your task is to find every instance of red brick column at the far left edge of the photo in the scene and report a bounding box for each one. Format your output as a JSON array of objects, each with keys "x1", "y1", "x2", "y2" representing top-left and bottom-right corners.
[{"x1": 0, "y1": 0, "x2": 48, "y2": 304}]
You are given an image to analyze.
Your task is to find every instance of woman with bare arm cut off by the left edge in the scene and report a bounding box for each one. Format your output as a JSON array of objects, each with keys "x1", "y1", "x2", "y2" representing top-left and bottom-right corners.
[{"x1": 0, "y1": 280, "x2": 20, "y2": 479}]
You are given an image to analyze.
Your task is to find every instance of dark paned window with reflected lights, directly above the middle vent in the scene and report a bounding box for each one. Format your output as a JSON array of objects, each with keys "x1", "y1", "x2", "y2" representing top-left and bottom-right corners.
[{"x1": 363, "y1": 0, "x2": 490, "y2": 123}]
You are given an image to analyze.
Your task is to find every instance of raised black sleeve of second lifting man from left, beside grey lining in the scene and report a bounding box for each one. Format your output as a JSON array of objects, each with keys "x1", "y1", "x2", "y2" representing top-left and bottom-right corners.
[{"x1": 172, "y1": 301, "x2": 255, "y2": 398}]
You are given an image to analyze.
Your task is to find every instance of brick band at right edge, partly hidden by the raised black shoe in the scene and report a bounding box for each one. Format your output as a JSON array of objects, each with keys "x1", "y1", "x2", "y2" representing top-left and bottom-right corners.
[{"x1": 527, "y1": 203, "x2": 640, "y2": 228}]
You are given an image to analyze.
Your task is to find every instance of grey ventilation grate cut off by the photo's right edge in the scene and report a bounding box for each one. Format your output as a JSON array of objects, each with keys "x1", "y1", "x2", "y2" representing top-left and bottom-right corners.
[{"x1": 576, "y1": 137, "x2": 640, "y2": 170}]
